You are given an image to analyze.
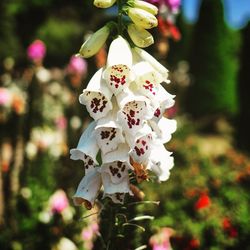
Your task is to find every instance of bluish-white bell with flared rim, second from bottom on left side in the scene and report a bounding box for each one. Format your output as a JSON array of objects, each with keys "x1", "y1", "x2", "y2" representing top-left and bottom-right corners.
[{"x1": 70, "y1": 122, "x2": 99, "y2": 173}]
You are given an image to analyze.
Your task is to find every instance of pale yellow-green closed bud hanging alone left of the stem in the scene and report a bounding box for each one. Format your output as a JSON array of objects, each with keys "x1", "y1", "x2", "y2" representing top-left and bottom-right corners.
[{"x1": 79, "y1": 24, "x2": 112, "y2": 58}]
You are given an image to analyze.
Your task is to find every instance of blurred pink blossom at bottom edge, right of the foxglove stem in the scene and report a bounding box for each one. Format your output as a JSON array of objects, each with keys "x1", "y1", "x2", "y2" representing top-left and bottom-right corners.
[{"x1": 149, "y1": 227, "x2": 174, "y2": 250}]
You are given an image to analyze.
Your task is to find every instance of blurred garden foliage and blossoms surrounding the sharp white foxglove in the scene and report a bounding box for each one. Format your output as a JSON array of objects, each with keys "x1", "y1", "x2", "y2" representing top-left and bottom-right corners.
[{"x1": 0, "y1": 0, "x2": 250, "y2": 250}]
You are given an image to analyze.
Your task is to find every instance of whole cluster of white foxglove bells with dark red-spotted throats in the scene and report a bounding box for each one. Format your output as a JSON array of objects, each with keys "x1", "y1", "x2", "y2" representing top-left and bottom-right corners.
[{"x1": 70, "y1": 1, "x2": 176, "y2": 209}]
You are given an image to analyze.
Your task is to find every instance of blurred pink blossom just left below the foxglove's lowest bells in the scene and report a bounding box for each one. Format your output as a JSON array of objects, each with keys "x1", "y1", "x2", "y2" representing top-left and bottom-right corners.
[{"x1": 49, "y1": 189, "x2": 69, "y2": 213}]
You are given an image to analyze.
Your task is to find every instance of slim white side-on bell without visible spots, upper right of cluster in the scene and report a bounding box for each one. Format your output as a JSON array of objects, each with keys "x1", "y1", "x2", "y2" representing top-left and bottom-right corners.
[{"x1": 133, "y1": 47, "x2": 168, "y2": 81}]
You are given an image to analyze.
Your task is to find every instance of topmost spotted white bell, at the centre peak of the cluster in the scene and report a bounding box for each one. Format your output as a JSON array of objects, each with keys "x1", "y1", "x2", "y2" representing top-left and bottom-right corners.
[{"x1": 103, "y1": 36, "x2": 133, "y2": 95}]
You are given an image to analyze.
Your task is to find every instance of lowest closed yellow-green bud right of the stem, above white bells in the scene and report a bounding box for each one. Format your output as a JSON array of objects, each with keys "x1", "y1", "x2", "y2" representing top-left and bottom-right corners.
[{"x1": 128, "y1": 24, "x2": 154, "y2": 48}]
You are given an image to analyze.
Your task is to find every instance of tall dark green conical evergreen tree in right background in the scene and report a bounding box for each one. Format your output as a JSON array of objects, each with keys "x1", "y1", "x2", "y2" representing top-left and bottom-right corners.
[{"x1": 186, "y1": 0, "x2": 240, "y2": 117}]
